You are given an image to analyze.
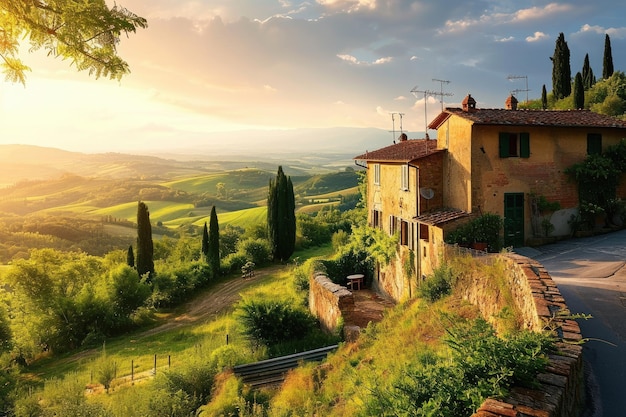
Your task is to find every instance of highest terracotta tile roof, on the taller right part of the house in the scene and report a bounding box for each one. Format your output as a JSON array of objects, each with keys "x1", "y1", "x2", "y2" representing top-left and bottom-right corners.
[{"x1": 428, "y1": 108, "x2": 626, "y2": 129}]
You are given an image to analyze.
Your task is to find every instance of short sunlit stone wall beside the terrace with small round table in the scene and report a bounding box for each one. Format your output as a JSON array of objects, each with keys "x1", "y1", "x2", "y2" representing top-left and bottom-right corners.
[{"x1": 309, "y1": 274, "x2": 354, "y2": 333}]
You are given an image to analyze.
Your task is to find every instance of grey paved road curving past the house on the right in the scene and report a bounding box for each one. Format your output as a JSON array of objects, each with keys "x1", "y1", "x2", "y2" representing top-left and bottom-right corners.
[{"x1": 516, "y1": 230, "x2": 626, "y2": 417}]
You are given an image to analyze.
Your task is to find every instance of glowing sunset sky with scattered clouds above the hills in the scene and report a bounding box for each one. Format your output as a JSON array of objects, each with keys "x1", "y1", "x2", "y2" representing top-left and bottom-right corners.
[{"x1": 0, "y1": 0, "x2": 626, "y2": 153}]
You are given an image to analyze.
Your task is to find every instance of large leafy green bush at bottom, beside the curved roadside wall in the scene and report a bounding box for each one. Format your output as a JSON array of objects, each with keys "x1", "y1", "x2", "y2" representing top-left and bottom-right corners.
[{"x1": 366, "y1": 319, "x2": 553, "y2": 417}]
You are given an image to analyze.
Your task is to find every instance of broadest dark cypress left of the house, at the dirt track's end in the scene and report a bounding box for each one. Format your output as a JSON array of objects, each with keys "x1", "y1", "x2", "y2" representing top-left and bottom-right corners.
[{"x1": 267, "y1": 166, "x2": 296, "y2": 261}]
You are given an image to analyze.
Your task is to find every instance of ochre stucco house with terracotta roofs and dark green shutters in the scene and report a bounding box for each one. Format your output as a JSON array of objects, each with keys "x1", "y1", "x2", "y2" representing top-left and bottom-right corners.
[{"x1": 354, "y1": 95, "x2": 626, "y2": 300}]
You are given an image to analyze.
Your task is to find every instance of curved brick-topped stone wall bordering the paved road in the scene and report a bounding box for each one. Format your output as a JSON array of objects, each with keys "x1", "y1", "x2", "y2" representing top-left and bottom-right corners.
[{"x1": 467, "y1": 254, "x2": 584, "y2": 417}]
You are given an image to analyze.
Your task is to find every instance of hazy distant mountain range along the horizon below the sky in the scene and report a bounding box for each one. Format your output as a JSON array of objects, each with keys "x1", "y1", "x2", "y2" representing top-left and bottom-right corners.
[{"x1": 0, "y1": 128, "x2": 411, "y2": 186}]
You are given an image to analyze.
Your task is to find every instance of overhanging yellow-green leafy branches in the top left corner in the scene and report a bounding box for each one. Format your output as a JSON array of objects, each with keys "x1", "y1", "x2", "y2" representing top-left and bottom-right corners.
[{"x1": 0, "y1": 0, "x2": 148, "y2": 84}]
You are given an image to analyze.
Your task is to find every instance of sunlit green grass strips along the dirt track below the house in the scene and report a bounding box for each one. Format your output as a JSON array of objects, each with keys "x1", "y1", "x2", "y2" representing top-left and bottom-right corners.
[{"x1": 23, "y1": 244, "x2": 332, "y2": 383}]
